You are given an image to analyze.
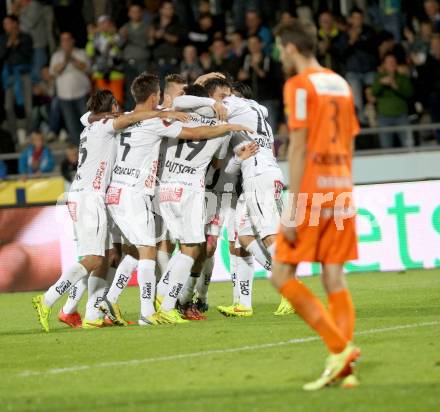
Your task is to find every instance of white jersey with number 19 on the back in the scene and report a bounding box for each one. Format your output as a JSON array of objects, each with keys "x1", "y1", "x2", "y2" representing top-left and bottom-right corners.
[{"x1": 161, "y1": 113, "x2": 230, "y2": 190}]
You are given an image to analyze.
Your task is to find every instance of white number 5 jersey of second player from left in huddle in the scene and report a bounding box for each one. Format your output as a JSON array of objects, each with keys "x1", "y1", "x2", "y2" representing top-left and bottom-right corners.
[{"x1": 111, "y1": 117, "x2": 183, "y2": 196}]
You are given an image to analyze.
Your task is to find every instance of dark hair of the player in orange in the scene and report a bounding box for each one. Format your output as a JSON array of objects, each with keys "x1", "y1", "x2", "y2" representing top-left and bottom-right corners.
[{"x1": 275, "y1": 21, "x2": 316, "y2": 57}]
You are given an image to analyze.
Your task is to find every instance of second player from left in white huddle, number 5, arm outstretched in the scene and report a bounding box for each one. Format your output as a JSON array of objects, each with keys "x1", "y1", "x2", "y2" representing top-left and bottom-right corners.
[{"x1": 100, "y1": 73, "x2": 247, "y2": 326}]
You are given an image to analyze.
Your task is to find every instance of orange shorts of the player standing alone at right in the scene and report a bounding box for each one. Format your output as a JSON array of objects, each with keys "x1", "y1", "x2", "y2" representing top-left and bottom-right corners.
[{"x1": 274, "y1": 208, "x2": 358, "y2": 264}]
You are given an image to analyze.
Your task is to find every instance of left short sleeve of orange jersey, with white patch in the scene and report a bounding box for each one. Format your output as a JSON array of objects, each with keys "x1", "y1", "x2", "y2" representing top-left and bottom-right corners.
[{"x1": 284, "y1": 76, "x2": 311, "y2": 130}]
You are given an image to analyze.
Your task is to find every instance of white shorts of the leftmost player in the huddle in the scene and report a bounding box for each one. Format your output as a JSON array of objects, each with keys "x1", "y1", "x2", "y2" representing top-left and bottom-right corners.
[{"x1": 67, "y1": 192, "x2": 108, "y2": 256}]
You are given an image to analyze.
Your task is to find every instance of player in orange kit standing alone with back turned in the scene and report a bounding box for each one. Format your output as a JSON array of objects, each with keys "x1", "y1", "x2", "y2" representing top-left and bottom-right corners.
[{"x1": 272, "y1": 23, "x2": 360, "y2": 391}]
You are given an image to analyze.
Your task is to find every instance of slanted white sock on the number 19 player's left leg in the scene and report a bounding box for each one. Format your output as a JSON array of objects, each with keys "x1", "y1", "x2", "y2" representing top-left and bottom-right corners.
[{"x1": 161, "y1": 253, "x2": 194, "y2": 312}]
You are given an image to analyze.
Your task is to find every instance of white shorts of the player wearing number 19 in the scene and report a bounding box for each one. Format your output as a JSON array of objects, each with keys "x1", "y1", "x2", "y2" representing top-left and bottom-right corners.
[{"x1": 159, "y1": 185, "x2": 206, "y2": 244}]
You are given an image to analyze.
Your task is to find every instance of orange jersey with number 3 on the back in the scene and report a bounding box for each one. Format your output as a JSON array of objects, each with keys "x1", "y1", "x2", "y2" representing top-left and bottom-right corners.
[{"x1": 284, "y1": 68, "x2": 359, "y2": 202}]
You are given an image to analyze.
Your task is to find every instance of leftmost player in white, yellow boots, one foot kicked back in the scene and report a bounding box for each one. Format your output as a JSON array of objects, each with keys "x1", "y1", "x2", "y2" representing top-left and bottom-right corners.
[{"x1": 32, "y1": 90, "x2": 182, "y2": 332}]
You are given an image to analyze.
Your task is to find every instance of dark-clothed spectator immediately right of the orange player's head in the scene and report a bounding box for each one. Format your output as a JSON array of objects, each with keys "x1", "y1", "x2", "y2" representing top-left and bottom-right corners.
[{"x1": 318, "y1": 11, "x2": 343, "y2": 73}]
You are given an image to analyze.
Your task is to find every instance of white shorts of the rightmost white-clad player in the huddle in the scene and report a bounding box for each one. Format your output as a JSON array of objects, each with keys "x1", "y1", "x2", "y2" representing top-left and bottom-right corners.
[{"x1": 237, "y1": 172, "x2": 283, "y2": 239}]
